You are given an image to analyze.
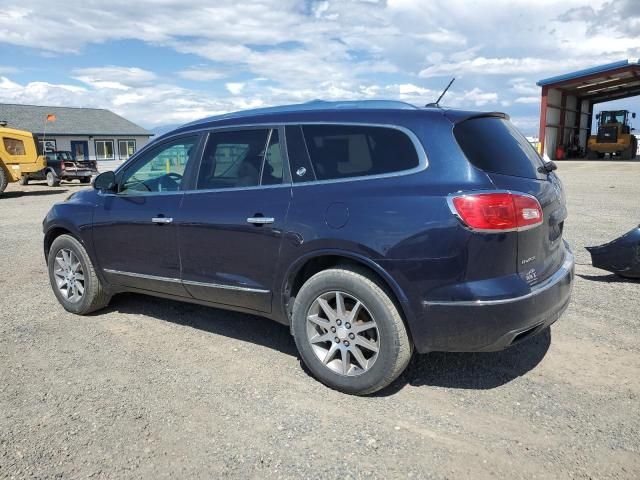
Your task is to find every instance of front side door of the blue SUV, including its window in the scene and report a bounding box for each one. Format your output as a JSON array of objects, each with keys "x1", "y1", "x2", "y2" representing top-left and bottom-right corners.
[{"x1": 93, "y1": 135, "x2": 199, "y2": 296}]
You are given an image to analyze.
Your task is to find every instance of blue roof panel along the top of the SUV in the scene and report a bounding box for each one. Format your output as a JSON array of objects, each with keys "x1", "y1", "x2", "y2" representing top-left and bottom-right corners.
[{"x1": 184, "y1": 100, "x2": 419, "y2": 126}]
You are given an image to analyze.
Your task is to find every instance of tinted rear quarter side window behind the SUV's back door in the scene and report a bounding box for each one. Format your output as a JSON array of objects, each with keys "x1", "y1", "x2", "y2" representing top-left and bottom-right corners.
[{"x1": 302, "y1": 125, "x2": 419, "y2": 180}]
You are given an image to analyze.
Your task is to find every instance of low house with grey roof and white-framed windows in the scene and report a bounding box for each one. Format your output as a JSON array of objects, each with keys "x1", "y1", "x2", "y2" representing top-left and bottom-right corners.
[{"x1": 0, "y1": 103, "x2": 153, "y2": 171}]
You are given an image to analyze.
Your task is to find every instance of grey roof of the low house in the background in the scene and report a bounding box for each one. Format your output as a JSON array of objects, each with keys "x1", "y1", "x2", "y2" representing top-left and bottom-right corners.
[{"x1": 0, "y1": 103, "x2": 153, "y2": 136}]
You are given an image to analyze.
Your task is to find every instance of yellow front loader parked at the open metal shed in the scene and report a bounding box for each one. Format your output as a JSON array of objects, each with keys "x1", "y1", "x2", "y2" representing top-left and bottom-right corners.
[{"x1": 587, "y1": 110, "x2": 638, "y2": 160}]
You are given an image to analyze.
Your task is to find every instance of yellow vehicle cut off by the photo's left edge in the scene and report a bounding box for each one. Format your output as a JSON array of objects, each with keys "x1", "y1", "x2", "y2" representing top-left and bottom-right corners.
[{"x1": 0, "y1": 122, "x2": 47, "y2": 195}]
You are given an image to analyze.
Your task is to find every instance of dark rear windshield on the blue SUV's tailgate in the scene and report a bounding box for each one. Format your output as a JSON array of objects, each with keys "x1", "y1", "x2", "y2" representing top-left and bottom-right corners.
[{"x1": 453, "y1": 117, "x2": 545, "y2": 179}]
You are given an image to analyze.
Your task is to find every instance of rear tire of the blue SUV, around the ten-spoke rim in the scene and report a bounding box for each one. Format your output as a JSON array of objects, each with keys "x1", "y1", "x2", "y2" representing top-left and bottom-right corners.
[{"x1": 292, "y1": 266, "x2": 413, "y2": 395}]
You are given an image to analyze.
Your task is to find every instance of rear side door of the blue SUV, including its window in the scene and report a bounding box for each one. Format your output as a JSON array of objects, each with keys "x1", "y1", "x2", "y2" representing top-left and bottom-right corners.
[{"x1": 178, "y1": 127, "x2": 291, "y2": 312}]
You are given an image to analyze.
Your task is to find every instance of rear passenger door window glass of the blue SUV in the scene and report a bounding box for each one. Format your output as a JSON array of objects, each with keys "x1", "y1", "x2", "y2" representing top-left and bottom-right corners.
[{"x1": 197, "y1": 129, "x2": 272, "y2": 190}]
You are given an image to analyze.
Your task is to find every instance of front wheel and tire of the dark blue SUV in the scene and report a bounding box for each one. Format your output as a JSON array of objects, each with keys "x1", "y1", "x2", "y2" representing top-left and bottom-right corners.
[{"x1": 47, "y1": 235, "x2": 111, "y2": 315}]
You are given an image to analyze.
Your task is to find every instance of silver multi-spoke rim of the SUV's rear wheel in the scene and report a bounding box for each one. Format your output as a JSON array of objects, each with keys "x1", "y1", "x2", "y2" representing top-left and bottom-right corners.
[{"x1": 307, "y1": 291, "x2": 380, "y2": 376}]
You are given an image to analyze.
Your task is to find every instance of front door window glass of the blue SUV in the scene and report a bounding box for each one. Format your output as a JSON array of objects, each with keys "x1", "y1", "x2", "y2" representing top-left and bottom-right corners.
[{"x1": 120, "y1": 137, "x2": 197, "y2": 194}]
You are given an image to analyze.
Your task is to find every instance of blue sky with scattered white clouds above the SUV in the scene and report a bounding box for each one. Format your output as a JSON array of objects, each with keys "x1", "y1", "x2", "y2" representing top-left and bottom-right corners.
[{"x1": 0, "y1": 0, "x2": 640, "y2": 134}]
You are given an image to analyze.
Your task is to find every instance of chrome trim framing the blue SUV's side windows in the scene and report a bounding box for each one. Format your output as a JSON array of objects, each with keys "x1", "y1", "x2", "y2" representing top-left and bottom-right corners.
[{"x1": 139, "y1": 120, "x2": 429, "y2": 193}]
